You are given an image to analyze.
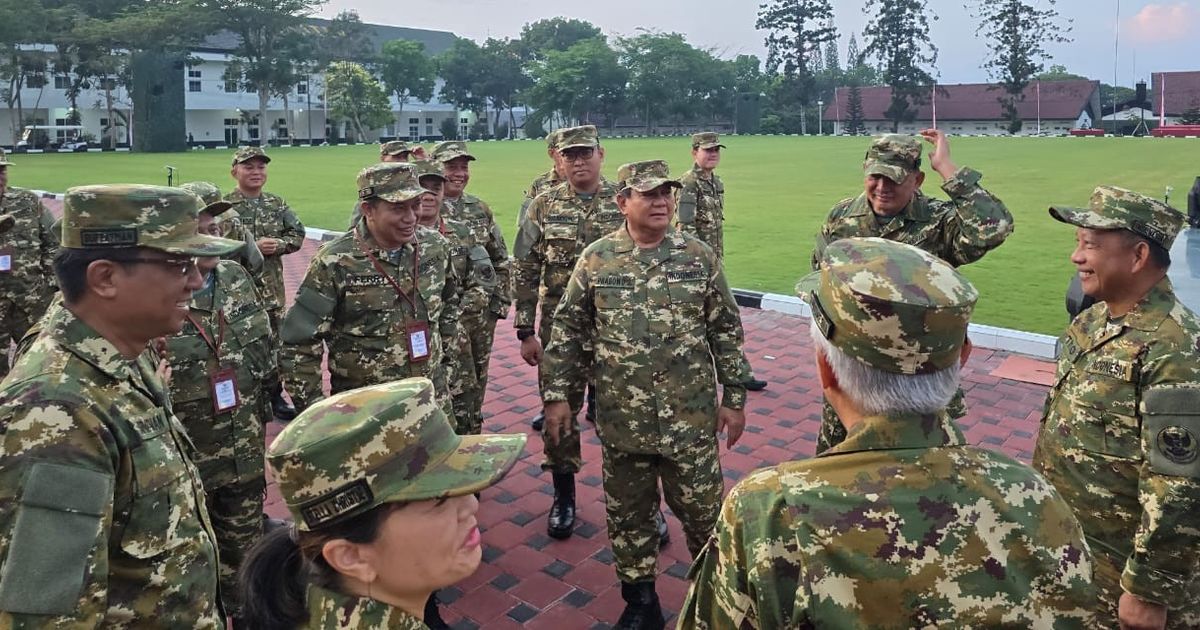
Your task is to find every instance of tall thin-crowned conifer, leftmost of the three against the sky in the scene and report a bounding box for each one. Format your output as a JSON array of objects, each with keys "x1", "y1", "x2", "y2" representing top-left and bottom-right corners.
[{"x1": 755, "y1": 0, "x2": 838, "y2": 133}]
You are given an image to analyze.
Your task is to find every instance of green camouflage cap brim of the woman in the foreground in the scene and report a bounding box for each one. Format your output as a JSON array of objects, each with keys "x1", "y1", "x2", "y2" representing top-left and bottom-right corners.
[{"x1": 377, "y1": 433, "x2": 526, "y2": 503}]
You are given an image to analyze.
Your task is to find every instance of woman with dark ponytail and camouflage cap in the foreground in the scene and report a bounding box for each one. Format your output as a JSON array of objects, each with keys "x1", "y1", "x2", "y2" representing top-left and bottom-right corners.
[{"x1": 241, "y1": 378, "x2": 526, "y2": 630}]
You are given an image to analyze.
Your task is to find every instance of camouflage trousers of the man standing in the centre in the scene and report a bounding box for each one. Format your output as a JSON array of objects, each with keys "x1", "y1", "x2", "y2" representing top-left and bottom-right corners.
[{"x1": 601, "y1": 437, "x2": 725, "y2": 583}]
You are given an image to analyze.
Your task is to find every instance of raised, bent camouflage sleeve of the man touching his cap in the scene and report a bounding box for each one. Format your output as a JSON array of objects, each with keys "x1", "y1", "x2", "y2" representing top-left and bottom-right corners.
[{"x1": 940, "y1": 168, "x2": 1013, "y2": 266}]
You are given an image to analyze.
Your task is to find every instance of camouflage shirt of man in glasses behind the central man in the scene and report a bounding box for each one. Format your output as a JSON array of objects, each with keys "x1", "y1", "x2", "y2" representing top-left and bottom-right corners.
[{"x1": 512, "y1": 179, "x2": 625, "y2": 328}]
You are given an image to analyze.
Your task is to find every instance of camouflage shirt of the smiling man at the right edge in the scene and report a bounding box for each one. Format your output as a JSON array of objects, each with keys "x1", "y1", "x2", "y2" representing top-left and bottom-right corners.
[{"x1": 1033, "y1": 278, "x2": 1200, "y2": 620}]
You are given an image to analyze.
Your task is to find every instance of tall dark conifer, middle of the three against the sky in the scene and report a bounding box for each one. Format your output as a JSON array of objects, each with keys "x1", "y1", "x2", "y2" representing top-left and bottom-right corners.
[{"x1": 863, "y1": 0, "x2": 937, "y2": 132}]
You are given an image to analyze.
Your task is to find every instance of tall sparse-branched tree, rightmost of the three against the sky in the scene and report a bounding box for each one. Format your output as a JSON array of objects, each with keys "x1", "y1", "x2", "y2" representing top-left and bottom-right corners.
[{"x1": 967, "y1": 0, "x2": 1070, "y2": 133}]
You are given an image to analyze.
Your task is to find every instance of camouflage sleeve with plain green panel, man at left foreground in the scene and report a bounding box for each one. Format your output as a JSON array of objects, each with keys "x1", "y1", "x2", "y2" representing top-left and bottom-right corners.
[{"x1": 0, "y1": 389, "x2": 119, "y2": 628}]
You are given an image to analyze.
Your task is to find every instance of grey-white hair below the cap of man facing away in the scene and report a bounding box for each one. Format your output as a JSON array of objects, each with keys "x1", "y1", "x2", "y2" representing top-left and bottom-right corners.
[{"x1": 809, "y1": 325, "x2": 959, "y2": 415}]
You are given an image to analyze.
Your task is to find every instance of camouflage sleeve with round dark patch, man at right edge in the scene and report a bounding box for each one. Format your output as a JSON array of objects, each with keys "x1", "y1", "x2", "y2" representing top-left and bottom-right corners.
[{"x1": 1121, "y1": 376, "x2": 1200, "y2": 608}]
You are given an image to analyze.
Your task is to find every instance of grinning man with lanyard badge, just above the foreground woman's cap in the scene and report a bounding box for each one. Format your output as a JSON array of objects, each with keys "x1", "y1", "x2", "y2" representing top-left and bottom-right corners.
[{"x1": 280, "y1": 163, "x2": 462, "y2": 418}]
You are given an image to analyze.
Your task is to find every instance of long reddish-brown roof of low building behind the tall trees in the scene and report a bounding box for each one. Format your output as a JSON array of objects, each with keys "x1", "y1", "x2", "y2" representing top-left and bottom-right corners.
[{"x1": 824, "y1": 79, "x2": 1099, "y2": 120}]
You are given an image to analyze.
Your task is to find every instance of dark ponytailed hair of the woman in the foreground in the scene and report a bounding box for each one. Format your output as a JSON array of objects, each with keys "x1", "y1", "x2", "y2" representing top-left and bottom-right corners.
[{"x1": 238, "y1": 503, "x2": 404, "y2": 630}]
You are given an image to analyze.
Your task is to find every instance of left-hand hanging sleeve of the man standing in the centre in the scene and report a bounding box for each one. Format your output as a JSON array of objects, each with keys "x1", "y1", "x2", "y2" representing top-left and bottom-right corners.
[{"x1": 541, "y1": 257, "x2": 595, "y2": 402}]
